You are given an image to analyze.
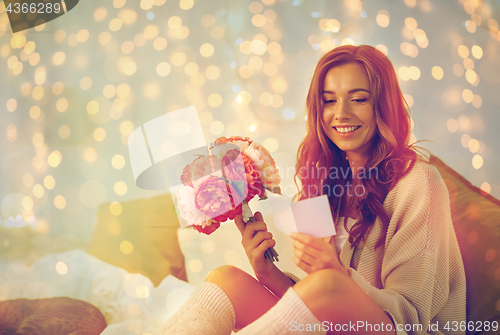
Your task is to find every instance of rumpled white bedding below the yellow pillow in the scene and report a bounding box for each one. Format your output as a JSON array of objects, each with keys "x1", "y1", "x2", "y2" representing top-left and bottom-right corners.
[{"x1": 0, "y1": 250, "x2": 194, "y2": 335}]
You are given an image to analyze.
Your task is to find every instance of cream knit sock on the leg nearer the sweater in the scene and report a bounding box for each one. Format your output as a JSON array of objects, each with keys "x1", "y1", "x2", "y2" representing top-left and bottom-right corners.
[{"x1": 238, "y1": 287, "x2": 326, "y2": 335}]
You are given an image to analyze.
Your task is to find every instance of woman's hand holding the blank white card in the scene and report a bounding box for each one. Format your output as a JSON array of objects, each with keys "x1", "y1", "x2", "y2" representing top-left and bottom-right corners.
[{"x1": 290, "y1": 232, "x2": 349, "y2": 274}]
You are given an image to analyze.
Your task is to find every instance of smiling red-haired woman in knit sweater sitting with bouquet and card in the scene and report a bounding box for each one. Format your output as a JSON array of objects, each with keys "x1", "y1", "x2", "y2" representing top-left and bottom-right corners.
[{"x1": 163, "y1": 45, "x2": 465, "y2": 334}]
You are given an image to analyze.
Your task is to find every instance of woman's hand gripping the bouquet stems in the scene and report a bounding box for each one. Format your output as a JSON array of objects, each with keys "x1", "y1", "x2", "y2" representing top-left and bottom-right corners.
[{"x1": 234, "y1": 212, "x2": 276, "y2": 281}]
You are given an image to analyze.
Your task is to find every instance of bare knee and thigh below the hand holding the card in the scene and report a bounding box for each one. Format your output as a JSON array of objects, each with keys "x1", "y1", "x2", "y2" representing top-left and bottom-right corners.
[{"x1": 293, "y1": 269, "x2": 395, "y2": 335}]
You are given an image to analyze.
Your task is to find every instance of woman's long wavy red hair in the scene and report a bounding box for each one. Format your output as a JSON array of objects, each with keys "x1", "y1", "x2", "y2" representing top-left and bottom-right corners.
[{"x1": 295, "y1": 45, "x2": 418, "y2": 247}]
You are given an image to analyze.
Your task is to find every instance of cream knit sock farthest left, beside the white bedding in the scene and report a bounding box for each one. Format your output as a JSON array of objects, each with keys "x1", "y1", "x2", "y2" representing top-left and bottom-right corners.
[{"x1": 157, "y1": 282, "x2": 236, "y2": 335}]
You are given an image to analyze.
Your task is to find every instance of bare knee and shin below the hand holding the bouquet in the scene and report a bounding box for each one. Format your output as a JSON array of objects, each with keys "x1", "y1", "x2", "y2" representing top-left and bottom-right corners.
[{"x1": 205, "y1": 265, "x2": 278, "y2": 329}]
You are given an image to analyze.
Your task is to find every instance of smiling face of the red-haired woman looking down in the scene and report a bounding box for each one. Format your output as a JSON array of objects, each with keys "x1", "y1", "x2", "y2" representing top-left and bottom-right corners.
[{"x1": 322, "y1": 63, "x2": 377, "y2": 162}]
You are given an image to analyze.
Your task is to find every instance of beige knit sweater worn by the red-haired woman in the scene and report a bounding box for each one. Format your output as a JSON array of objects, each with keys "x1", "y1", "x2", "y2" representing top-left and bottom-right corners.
[{"x1": 340, "y1": 162, "x2": 466, "y2": 334}]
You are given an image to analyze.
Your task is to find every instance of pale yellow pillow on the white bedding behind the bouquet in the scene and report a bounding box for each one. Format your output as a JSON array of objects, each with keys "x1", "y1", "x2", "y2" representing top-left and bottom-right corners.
[{"x1": 88, "y1": 194, "x2": 187, "y2": 286}]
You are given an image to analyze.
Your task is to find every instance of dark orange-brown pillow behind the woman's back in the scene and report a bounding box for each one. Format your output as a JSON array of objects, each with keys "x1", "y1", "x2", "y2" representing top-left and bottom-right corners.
[{"x1": 430, "y1": 156, "x2": 500, "y2": 334}]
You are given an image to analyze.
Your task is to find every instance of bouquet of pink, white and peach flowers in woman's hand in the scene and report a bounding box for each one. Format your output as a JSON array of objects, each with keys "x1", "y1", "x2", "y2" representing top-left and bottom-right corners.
[{"x1": 176, "y1": 136, "x2": 281, "y2": 262}]
